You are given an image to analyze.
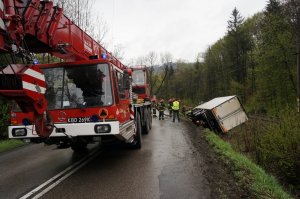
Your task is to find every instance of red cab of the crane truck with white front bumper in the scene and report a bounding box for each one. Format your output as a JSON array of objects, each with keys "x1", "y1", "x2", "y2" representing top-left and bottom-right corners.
[{"x1": 1, "y1": 59, "x2": 147, "y2": 151}]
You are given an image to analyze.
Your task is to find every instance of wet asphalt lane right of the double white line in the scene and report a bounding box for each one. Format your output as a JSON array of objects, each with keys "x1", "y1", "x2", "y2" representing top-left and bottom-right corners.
[{"x1": 43, "y1": 118, "x2": 210, "y2": 199}]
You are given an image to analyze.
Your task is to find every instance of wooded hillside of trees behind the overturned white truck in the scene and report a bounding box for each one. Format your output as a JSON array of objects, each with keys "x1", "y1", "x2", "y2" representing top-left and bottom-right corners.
[{"x1": 152, "y1": 1, "x2": 300, "y2": 115}]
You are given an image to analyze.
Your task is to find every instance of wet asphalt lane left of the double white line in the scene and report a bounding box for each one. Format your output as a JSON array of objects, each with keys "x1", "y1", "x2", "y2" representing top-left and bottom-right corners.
[{"x1": 0, "y1": 144, "x2": 97, "y2": 199}]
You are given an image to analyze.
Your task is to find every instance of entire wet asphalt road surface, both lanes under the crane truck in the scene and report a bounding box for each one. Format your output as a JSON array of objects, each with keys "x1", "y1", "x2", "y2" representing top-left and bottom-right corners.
[{"x1": 0, "y1": 118, "x2": 211, "y2": 199}]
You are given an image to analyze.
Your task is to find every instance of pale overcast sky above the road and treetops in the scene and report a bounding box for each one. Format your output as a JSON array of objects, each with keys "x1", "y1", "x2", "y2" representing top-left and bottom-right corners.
[{"x1": 95, "y1": 0, "x2": 267, "y2": 64}]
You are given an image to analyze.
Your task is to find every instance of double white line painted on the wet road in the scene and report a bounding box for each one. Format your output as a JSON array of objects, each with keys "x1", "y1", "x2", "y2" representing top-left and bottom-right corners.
[{"x1": 20, "y1": 150, "x2": 101, "y2": 199}]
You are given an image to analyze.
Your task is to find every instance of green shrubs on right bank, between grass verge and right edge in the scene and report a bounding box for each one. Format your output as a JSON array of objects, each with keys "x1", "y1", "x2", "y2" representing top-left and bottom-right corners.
[{"x1": 229, "y1": 107, "x2": 300, "y2": 193}]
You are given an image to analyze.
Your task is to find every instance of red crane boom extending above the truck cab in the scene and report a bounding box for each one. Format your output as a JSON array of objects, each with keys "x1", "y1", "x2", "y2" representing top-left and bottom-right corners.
[{"x1": 0, "y1": 0, "x2": 124, "y2": 69}]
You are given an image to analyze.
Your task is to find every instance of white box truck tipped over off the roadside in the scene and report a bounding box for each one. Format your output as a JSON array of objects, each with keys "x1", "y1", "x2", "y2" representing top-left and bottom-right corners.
[{"x1": 189, "y1": 96, "x2": 248, "y2": 133}]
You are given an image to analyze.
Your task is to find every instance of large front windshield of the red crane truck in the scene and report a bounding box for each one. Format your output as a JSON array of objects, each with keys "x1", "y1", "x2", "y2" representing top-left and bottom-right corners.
[{"x1": 43, "y1": 64, "x2": 113, "y2": 110}]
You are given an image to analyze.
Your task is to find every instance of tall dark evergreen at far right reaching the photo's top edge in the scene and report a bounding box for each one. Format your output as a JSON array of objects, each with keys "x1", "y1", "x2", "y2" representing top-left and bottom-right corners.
[{"x1": 255, "y1": 0, "x2": 296, "y2": 114}]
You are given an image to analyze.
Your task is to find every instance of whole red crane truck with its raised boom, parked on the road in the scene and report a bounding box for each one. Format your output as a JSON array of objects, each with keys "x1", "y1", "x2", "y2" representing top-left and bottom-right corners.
[{"x1": 0, "y1": 0, "x2": 152, "y2": 151}]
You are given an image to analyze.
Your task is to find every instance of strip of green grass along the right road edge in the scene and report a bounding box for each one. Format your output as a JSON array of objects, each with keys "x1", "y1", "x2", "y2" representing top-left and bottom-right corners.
[{"x1": 206, "y1": 132, "x2": 292, "y2": 199}]
